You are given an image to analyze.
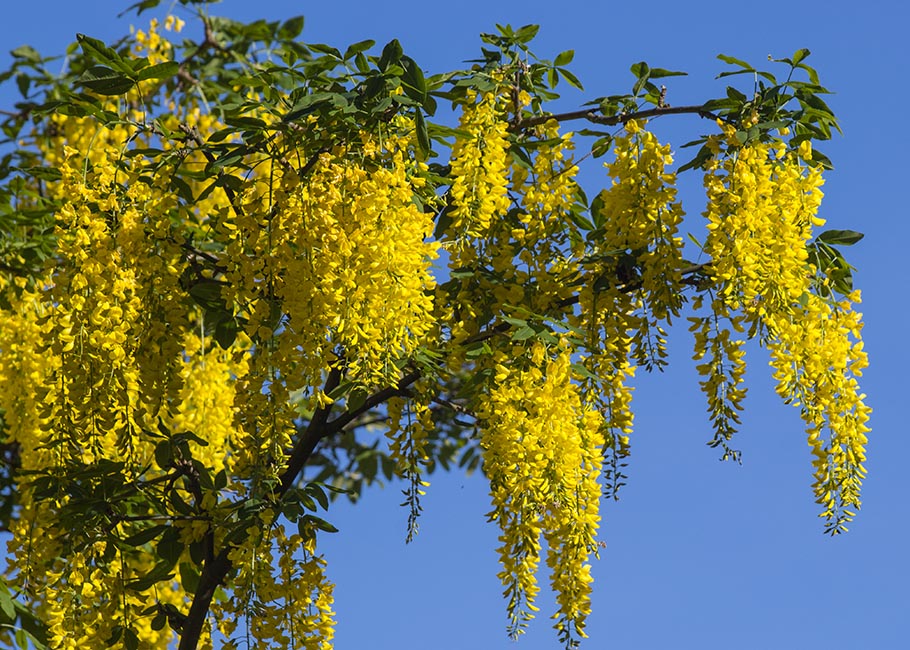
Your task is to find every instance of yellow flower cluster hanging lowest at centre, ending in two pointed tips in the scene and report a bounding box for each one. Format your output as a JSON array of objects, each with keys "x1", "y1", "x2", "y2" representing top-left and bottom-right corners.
[{"x1": 478, "y1": 343, "x2": 604, "y2": 640}]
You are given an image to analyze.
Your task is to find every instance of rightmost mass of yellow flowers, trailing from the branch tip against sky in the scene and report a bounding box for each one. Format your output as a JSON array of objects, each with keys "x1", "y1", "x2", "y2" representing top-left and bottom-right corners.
[{"x1": 693, "y1": 126, "x2": 871, "y2": 533}]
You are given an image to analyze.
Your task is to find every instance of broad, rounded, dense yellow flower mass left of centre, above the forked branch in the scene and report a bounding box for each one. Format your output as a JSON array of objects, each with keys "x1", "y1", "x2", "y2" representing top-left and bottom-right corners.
[{"x1": 219, "y1": 140, "x2": 436, "y2": 390}]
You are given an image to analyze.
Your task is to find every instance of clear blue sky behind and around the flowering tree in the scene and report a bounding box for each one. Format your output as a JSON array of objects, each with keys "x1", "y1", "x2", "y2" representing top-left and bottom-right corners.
[{"x1": 0, "y1": 0, "x2": 910, "y2": 650}]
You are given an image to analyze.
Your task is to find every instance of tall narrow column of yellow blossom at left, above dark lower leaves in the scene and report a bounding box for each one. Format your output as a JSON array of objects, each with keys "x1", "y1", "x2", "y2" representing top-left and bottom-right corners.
[{"x1": 48, "y1": 151, "x2": 144, "y2": 462}]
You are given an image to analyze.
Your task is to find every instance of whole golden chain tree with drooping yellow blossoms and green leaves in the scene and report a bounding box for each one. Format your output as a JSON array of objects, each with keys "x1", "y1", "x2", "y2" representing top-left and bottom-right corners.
[{"x1": 0, "y1": 5, "x2": 869, "y2": 650}]
